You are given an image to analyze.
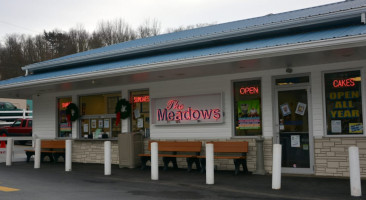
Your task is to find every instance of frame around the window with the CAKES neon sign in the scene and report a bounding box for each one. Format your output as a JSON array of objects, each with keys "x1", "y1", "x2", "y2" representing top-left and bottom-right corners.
[{"x1": 321, "y1": 67, "x2": 366, "y2": 138}]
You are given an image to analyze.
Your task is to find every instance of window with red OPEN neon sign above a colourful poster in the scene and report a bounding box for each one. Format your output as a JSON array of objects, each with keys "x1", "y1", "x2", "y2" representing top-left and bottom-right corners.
[{"x1": 234, "y1": 80, "x2": 262, "y2": 136}]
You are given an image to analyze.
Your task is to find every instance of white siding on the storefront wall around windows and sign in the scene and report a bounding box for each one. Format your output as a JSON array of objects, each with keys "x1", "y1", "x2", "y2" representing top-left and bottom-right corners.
[{"x1": 33, "y1": 61, "x2": 366, "y2": 139}]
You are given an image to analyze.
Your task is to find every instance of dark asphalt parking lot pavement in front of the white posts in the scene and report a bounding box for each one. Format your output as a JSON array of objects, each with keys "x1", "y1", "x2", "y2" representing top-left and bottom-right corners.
[{"x1": 0, "y1": 162, "x2": 366, "y2": 200}]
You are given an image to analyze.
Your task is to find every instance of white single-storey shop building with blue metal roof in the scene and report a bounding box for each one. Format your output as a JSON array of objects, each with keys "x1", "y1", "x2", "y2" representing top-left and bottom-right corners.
[{"x1": 0, "y1": 0, "x2": 366, "y2": 177}]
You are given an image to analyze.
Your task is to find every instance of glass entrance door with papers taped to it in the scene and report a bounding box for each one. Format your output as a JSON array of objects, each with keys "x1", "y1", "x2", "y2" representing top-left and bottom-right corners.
[{"x1": 276, "y1": 87, "x2": 313, "y2": 173}]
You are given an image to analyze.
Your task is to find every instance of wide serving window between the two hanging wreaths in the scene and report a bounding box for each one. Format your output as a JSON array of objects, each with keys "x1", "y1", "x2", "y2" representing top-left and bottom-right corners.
[{"x1": 80, "y1": 93, "x2": 121, "y2": 139}]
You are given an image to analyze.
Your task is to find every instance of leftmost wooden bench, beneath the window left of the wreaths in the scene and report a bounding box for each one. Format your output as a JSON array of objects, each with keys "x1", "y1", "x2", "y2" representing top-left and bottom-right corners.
[{"x1": 24, "y1": 140, "x2": 65, "y2": 162}]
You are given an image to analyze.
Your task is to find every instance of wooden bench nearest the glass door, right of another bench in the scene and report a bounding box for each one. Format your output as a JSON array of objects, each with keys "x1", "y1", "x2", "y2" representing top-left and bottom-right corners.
[{"x1": 198, "y1": 141, "x2": 249, "y2": 175}]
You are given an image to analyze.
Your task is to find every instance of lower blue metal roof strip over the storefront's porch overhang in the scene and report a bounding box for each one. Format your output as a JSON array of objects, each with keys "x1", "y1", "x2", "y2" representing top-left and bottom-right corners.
[{"x1": 0, "y1": 25, "x2": 366, "y2": 86}]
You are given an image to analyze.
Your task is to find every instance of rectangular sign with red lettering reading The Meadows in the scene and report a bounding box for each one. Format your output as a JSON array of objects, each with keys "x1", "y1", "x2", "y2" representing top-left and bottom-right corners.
[{"x1": 151, "y1": 93, "x2": 223, "y2": 125}]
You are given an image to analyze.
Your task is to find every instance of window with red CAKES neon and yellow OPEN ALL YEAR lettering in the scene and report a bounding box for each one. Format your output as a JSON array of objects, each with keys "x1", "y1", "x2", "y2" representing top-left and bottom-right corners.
[{"x1": 324, "y1": 71, "x2": 363, "y2": 135}]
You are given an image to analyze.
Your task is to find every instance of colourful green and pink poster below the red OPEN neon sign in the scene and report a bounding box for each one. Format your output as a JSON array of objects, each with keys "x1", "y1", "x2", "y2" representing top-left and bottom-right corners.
[{"x1": 238, "y1": 100, "x2": 261, "y2": 129}]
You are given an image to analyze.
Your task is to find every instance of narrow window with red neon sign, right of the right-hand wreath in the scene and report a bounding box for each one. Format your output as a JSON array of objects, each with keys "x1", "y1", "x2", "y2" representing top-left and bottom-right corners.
[{"x1": 130, "y1": 90, "x2": 150, "y2": 137}]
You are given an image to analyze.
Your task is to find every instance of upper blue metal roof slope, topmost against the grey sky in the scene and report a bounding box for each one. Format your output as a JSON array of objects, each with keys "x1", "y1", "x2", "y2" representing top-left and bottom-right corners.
[{"x1": 26, "y1": 0, "x2": 366, "y2": 70}]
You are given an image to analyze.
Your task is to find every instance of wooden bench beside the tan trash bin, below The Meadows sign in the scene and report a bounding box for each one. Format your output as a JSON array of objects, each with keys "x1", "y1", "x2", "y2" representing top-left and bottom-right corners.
[{"x1": 138, "y1": 141, "x2": 202, "y2": 171}]
